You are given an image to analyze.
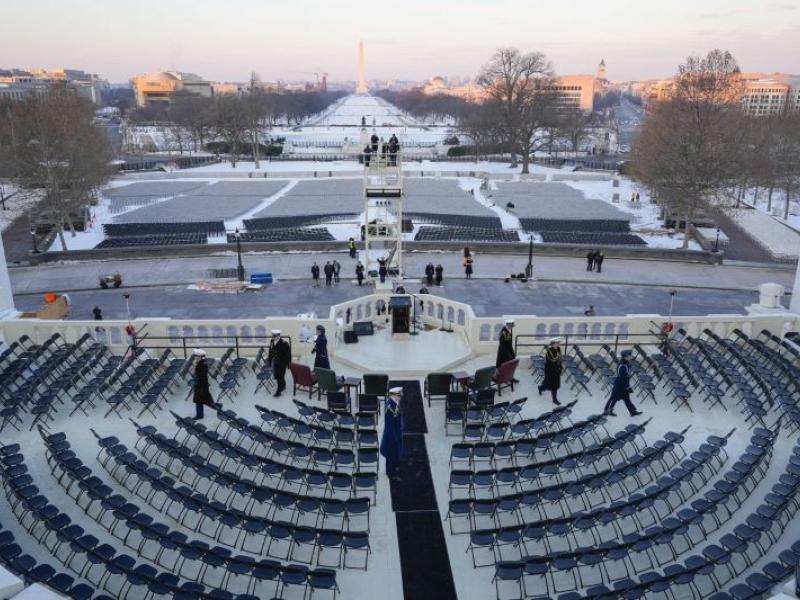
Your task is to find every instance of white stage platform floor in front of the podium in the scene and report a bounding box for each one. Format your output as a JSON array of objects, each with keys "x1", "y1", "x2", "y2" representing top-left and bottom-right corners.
[{"x1": 334, "y1": 329, "x2": 472, "y2": 378}]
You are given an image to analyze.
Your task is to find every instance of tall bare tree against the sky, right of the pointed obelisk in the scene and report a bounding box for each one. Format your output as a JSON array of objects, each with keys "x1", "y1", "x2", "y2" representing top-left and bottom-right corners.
[{"x1": 478, "y1": 48, "x2": 557, "y2": 173}]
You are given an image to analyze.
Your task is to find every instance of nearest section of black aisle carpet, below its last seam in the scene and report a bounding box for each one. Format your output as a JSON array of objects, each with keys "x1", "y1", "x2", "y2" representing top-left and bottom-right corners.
[{"x1": 395, "y1": 510, "x2": 457, "y2": 600}]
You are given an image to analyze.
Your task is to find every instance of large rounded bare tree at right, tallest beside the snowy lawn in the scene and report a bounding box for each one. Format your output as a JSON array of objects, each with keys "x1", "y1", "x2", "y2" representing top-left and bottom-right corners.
[{"x1": 632, "y1": 50, "x2": 747, "y2": 248}]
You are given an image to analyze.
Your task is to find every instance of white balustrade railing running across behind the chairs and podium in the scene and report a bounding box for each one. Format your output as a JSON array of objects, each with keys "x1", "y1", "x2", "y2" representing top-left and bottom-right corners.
[{"x1": 0, "y1": 294, "x2": 800, "y2": 360}]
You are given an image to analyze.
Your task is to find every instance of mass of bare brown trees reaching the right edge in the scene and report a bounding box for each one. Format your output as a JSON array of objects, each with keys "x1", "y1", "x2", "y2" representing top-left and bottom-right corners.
[{"x1": 631, "y1": 50, "x2": 800, "y2": 247}]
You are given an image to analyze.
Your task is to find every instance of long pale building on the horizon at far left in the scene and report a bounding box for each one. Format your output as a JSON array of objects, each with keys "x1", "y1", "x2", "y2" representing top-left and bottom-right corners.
[{"x1": 0, "y1": 69, "x2": 109, "y2": 104}]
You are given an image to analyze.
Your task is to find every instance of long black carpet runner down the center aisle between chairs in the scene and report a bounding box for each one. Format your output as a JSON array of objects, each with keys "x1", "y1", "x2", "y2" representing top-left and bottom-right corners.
[{"x1": 389, "y1": 381, "x2": 457, "y2": 600}]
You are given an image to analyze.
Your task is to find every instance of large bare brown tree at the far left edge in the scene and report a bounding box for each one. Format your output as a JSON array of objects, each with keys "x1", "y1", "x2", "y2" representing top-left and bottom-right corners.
[{"x1": 0, "y1": 85, "x2": 111, "y2": 250}]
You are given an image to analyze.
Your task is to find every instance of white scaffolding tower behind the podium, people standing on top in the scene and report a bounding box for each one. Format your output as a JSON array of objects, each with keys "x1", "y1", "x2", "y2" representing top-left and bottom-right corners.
[{"x1": 362, "y1": 152, "x2": 404, "y2": 280}]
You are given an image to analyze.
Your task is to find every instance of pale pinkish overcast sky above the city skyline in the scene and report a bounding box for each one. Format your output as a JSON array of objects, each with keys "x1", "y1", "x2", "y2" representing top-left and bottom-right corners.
[{"x1": 0, "y1": 0, "x2": 800, "y2": 82}]
